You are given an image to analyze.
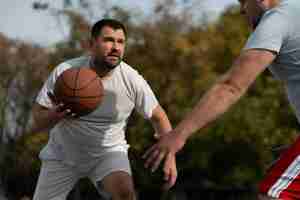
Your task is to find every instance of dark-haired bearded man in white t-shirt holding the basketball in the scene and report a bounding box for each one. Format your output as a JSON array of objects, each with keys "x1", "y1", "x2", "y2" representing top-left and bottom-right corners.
[{"x1": 33, "y1": 19, "x2": 177, "y2": 200}]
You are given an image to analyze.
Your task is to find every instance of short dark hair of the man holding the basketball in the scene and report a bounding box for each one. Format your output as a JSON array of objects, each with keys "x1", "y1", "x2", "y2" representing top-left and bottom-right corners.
[{"x1": 91, "y1": 19, "x2": 127, "y2": 38}]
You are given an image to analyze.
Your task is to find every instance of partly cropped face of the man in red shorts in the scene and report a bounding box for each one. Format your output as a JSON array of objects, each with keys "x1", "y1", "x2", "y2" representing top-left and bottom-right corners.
[{"x1": 239, "y1": 0, "x2": 265, "y2": 29}]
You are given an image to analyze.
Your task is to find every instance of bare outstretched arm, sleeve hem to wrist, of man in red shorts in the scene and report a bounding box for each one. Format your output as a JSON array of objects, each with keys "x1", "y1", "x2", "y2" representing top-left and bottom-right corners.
[{"x1": 175, "y1": 50, "x2": 275, "y2": 139}]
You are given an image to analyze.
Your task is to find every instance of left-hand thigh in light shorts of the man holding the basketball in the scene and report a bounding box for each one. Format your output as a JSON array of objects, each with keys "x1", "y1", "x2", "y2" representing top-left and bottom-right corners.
[{"x1": 33, "y1": 161, "x2": 79, "y2": 200}]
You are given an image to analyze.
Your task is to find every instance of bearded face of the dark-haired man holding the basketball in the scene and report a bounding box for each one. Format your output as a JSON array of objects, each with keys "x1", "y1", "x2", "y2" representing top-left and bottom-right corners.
[{"x1": 92, "y1": 26, "x2": 126, "y2": 69}]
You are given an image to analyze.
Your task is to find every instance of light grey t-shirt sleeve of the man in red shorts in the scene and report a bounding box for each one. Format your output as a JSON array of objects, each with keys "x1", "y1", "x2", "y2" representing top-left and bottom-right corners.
[{"x1": 244, "y1": 10, "x2": 289, "y2": 53}]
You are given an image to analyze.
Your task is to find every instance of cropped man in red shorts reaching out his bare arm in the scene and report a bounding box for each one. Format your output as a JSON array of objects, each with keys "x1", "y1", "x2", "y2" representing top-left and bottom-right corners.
[{"x1": 144, "y1": 0, "x2": 300, "y2": 200}]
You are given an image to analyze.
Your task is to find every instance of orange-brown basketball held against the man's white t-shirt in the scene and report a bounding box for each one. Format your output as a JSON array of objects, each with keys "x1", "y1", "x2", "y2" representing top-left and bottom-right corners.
[{"x1": 54, "y1": 67, "x2": 104, "y2": 116}]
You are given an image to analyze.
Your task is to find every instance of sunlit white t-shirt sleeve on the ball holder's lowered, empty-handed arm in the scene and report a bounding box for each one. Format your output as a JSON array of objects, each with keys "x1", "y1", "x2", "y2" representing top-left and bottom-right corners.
[{"x1": 134, "y1": 72, "x2": 158, "y2": 119}]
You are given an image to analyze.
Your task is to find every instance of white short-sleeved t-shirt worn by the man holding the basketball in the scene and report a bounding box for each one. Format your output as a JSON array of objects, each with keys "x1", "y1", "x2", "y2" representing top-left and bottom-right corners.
[{"x1": 36, "y1": 56, "x2": 158, "y2": 164}]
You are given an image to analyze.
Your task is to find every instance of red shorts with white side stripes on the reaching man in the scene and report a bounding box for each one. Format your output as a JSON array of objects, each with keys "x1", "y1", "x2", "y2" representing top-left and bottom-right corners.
[{"x1": 259, "y1": 137, "x2": 300, "y2": 200}]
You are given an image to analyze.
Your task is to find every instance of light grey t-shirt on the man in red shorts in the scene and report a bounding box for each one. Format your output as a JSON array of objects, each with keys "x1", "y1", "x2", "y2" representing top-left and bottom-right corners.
[{"x1": 244, "y1": 0, "x2": 300, "y2": 121}]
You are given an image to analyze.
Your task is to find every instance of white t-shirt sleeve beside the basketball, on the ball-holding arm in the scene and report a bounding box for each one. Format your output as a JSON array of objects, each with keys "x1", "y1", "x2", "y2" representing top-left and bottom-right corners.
[{"x1": 35, "y1": 63, "x2": 71, "y2": 108}]
